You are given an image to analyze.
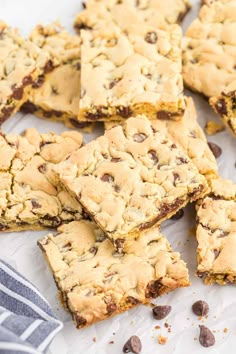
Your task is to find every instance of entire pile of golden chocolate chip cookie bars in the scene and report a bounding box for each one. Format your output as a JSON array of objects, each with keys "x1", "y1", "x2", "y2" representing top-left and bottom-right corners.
[{"x1": 0, "y1": 0, "x2": 236, "y2": 328}]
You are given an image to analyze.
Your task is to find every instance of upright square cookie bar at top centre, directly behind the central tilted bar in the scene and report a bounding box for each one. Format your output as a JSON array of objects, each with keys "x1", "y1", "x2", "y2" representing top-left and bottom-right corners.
[{"x1": 79, "y1": 25, "x2": 185, "y2": 122}]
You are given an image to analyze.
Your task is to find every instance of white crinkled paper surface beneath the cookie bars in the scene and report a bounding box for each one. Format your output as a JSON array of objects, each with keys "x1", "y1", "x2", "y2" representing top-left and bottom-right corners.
[{"x1": 0, "y1": 0, "x2": 236, "y2": 354}]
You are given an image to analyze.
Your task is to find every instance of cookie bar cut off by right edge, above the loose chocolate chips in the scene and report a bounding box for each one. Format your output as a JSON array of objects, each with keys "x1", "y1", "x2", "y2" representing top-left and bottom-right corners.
[{"x1": 197, "y1": 179, "x2": 236, "y2": 285}]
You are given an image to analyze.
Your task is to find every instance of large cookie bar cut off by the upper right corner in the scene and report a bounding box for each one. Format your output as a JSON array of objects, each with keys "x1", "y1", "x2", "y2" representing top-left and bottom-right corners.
[{"x1": 183, "y1": 0, "x2": 236, "y2": 134}]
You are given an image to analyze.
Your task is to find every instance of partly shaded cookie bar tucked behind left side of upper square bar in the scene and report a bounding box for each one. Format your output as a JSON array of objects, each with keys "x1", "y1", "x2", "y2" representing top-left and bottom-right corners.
[{"x1": 22, "y1": 22, "x2": 93, "y2": 131}]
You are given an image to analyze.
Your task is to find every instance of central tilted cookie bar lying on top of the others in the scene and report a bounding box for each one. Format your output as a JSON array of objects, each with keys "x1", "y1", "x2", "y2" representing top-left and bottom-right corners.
[{"x1": 55, "y1": 116, "x2": 208, "y2": 251}]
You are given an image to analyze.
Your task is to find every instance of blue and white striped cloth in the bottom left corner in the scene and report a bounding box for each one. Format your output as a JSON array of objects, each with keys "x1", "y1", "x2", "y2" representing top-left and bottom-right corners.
[{"x1": 0, "y1": 260, "x2": 63, "y2": 354}]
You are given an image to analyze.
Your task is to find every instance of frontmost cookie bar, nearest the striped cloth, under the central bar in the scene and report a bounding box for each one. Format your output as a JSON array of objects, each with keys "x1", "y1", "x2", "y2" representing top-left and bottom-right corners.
[{"x1": 38, "y1": 220, "x2": 189, "y2": 329}]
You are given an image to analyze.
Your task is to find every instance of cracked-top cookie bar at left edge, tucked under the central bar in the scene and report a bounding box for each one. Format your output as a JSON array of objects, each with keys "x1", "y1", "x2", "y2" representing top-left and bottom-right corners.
[{"x1": 0, "y1": 129, "x2": 83, "y2": 231}]
